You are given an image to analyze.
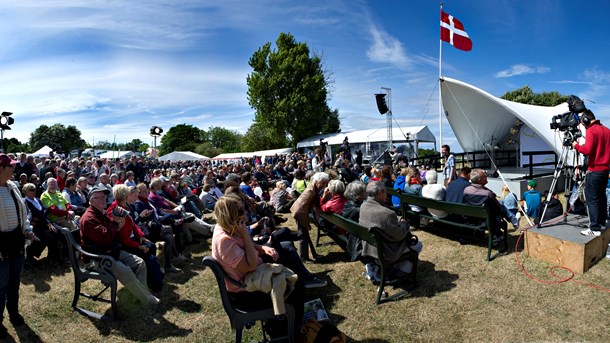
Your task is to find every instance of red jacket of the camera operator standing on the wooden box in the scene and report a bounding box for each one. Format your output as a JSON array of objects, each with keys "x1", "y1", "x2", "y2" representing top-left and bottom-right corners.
[{"x1": 574, "y1": 120, "x2": 610, "y2": 172}]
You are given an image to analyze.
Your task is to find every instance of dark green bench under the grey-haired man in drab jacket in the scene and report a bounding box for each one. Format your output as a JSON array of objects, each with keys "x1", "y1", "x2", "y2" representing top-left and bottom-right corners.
[{"x1": 318, "y1": 213, "x2": 418, "y2": 304}]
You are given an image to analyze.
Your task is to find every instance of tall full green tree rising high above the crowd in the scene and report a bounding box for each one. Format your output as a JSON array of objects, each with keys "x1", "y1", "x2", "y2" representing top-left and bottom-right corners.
[{"x1": 247, "y1": 33, "x2": 340, "y2": 149}]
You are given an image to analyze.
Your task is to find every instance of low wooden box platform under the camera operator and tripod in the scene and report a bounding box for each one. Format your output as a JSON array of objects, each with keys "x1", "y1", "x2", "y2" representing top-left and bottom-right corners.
[{"x1": 524, "y1": 214, "x2": 610, "y2": 273}]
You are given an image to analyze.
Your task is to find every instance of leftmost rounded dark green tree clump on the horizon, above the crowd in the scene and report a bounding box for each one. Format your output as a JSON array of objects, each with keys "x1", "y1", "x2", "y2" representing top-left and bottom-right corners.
[{"x1": 29, "y1": 124, "x2": 85, "y2": 152}]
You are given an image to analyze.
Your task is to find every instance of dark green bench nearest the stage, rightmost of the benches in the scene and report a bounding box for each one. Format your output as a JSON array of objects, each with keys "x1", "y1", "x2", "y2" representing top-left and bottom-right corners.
[{"x1": 387, "y1": 188, "x2": 508, "y2": 261}]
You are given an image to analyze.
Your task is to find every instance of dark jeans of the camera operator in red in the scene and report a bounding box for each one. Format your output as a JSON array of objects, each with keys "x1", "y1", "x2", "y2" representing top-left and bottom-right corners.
[{"x1": 585, "y1": 170, "x2": 608, "y2": 231}]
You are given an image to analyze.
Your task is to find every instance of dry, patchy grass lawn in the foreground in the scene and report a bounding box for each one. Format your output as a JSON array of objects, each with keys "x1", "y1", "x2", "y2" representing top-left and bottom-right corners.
[{"x1": 5, "y1": 215, "x2": 610, "y2": 342}]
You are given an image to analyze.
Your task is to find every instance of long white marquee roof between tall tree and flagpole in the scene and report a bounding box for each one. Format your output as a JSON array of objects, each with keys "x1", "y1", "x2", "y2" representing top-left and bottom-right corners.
[{"x1": 297, "y1": 126, "x2": 436, "y2": 148}]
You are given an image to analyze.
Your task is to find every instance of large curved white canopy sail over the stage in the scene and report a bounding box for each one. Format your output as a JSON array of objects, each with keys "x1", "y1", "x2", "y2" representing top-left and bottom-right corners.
[{"x1": 441, "y1": 77, "x2": 568, "y2": 154}]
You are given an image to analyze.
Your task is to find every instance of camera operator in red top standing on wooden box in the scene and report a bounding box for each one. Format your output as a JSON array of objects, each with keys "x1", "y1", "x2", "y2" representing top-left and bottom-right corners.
[{"x1": 572, "y1": 110, "x2": 610, "y2": 236}]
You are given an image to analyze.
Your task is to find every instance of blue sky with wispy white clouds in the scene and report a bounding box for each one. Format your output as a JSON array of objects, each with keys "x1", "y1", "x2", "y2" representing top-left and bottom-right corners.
[{"x1": 0, "y1": 0, "x2": 610, "y2": 150}]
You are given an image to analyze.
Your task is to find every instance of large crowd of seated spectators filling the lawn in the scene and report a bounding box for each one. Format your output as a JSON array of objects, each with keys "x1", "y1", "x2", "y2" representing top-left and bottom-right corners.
[{"x1": 5, "y1": 149, "x2": 568, "y2": 328}]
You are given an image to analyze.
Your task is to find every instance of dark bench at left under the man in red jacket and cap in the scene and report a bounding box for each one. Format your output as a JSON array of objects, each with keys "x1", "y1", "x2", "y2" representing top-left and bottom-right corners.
[{"x1": 60, "y1": 228, "x2": 119, "y2": 320}]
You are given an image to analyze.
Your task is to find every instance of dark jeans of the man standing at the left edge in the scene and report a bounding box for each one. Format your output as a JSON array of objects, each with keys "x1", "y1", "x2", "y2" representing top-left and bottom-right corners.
[{"x1": 0, "y1": 254, "x2": 25, "y2": 323}]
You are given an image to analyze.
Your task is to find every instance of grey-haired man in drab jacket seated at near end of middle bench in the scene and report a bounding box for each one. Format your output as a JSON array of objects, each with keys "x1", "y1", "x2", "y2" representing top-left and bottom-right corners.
[{"x1": 358, "y1": 181, "x2": 422, "y2": 281}]
